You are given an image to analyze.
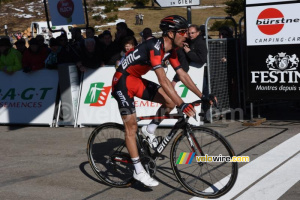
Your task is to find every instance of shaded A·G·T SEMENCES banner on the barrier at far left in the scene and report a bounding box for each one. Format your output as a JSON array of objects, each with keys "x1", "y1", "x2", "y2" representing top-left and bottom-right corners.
[{"x1": 0, "y1": 70, "x2": 58, "y2": 126}]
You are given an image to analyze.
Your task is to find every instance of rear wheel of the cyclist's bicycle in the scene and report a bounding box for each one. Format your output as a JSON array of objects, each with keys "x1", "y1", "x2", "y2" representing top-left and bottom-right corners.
[{"x1": 87, "y1": 123, "x2": 134, "y2": 187}]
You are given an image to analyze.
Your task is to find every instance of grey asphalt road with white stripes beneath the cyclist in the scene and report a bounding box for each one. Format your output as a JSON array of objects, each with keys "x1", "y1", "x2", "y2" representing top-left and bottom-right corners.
[{"x1": 0, "y1": 117, "x2": 300, "y2": 200}]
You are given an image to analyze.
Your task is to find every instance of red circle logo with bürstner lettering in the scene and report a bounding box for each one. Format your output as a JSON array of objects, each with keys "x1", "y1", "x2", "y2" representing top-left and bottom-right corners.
[{"x1": 256, "y1": 8, "x2": 299, "y2": 35}]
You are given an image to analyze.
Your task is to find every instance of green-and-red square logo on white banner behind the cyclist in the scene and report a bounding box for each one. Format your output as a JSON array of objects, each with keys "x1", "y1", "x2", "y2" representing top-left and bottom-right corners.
[{"x1": 84, "y1": 83, "x2": 111, "y2": 107}]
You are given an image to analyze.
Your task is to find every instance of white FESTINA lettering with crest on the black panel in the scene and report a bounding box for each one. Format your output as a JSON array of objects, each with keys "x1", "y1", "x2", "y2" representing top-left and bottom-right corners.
[{"x1": 251, "y1": 52, "x2": 300, "y2": 92}]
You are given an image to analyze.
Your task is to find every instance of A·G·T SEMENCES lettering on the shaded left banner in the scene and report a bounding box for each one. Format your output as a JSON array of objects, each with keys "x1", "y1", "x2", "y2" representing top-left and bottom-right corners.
[{"x1": 0, "y1": 87, "x2": 53, "y2": 108}]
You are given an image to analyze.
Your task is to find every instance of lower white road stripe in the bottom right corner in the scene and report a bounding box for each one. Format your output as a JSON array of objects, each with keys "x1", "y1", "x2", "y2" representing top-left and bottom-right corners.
[{"x1": 237, "y1": 154, "x2": 300, "y2": 200}]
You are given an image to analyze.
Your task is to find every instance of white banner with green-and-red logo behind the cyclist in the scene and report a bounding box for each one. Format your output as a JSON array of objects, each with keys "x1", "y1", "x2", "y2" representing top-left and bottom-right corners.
[{"x1": 77, "y1": 67, "x2": 204, "y2": 126}]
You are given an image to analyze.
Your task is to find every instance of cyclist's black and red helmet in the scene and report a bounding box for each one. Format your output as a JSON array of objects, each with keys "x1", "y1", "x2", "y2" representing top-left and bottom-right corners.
[{"x1": 159, "y1": 15, "x2": 188, "y2": 33}]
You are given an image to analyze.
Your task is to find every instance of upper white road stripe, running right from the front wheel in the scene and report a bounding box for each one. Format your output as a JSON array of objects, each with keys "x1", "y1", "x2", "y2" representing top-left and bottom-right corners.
[{"x1": 191, "y1": 133, "x2": 300, "y2": 200}]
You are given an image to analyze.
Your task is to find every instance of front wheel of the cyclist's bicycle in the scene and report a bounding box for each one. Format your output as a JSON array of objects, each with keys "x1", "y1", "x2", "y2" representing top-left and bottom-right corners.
[{"x1": 170, "y1": 127, "x2": 238, "y2": 198}]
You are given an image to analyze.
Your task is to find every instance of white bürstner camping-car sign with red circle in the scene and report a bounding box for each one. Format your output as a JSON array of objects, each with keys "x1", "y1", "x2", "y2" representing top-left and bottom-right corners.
[{"x1": 246, "y1": 3, "x2": 300, "y2": 46}]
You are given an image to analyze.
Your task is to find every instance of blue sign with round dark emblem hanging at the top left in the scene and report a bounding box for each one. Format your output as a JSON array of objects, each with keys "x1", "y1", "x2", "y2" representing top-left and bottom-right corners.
[{"x1": 48, "y1": 0, "x2": 85, "y2": 26}]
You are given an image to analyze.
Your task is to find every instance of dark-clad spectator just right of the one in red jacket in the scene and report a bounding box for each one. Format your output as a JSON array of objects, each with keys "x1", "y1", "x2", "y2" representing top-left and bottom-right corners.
[{"x1": 45, "y1": 38, "x2": 61, "y2": 69}]
